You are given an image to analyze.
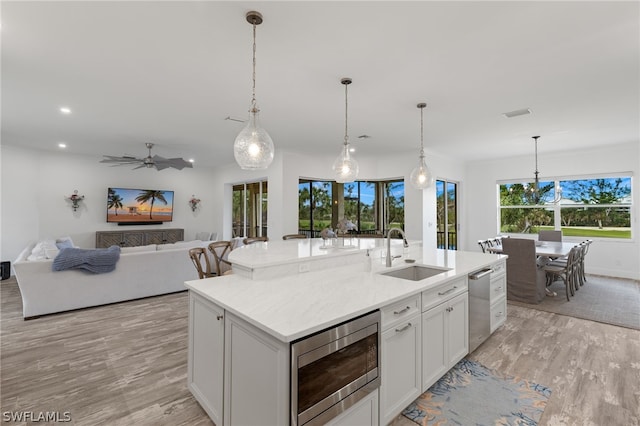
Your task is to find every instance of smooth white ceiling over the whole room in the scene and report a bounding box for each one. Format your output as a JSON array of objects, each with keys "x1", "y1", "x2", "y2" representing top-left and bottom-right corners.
[{"x1": 0, "y1": 1, "x2": 640, "y2": 167}]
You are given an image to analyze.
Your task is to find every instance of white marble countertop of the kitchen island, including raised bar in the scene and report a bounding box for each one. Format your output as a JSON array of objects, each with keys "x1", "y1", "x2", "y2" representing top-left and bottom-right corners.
[{"x1": 185, "y1": 239, "x2": 506, "y2": 342}]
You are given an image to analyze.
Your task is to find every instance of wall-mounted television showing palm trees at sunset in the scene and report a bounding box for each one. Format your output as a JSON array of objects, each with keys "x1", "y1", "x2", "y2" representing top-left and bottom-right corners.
[{"x1": 107, "y1": 188, "x2": 173, "y2": 225}]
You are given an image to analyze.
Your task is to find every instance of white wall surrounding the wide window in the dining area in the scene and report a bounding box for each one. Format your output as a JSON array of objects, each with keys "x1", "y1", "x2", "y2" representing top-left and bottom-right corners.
[{"x1": 463, "y1": 143, "x2": 640, "y2": 279}]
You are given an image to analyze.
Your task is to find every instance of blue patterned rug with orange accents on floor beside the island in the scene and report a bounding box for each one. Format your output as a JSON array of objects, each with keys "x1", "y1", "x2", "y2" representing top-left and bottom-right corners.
[{"x1": 402, "y1": 359, "x2": 551, "y2": 426}]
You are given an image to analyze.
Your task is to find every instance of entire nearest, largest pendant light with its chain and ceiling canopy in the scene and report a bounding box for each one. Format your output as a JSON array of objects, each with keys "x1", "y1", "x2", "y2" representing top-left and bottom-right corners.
[{"x1": 233, "y1": 11, "x2": 274, "y2": 170}]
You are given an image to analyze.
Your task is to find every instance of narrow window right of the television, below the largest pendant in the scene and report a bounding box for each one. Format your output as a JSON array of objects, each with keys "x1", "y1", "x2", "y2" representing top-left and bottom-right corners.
[{"x1": 231, "y1": 181, "x2": 267, "y2": 237}]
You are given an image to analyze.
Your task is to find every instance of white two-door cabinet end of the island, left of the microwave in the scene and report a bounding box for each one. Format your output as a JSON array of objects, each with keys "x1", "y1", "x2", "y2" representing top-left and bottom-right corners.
[{"x1": 187, "y1": 292, "x2": 290, "y2": 426}]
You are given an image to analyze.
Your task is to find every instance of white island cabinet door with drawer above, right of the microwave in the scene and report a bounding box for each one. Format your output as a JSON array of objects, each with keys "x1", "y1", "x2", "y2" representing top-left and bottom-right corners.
[{"x1": 380, "y1": 294, "x2": 422, "y2": 425}]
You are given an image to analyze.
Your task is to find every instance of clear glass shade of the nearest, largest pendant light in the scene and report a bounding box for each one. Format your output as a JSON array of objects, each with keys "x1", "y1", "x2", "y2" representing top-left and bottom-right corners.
[{"x1": 233, "y1": 108, "x2": 275, "y2": 170}]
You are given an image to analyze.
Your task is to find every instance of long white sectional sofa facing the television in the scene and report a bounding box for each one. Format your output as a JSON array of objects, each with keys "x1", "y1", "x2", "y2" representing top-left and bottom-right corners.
[{"x1": 13, "y1": 240, "x2": 210, "y2": 319}]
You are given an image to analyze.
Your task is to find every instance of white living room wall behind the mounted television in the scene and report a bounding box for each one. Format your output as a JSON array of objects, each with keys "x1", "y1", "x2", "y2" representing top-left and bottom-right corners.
[{"x1": 0, "y1": 145, "x2": 218, "y2": 261}]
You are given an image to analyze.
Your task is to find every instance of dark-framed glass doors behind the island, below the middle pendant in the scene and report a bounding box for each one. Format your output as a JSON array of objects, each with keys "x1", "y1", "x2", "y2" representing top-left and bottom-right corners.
[{"x1": 298, "y1": 179, "x2": 404, "y2": 237}]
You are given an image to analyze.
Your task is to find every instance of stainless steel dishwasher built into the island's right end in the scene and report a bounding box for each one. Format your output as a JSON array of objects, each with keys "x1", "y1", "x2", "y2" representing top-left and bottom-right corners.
[{"x1": 469, "y1": 268, "x2": 493, "y2": 353}]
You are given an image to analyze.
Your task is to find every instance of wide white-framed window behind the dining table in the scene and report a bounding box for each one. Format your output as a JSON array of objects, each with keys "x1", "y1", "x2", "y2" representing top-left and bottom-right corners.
[{"x1": 498, "y1": 175, "x2": 632, "y2": 239}]
